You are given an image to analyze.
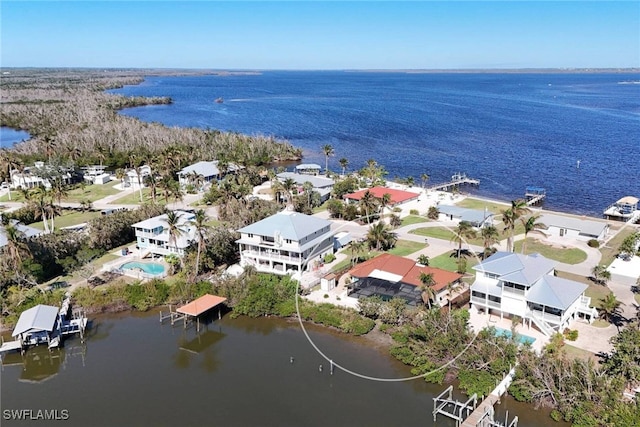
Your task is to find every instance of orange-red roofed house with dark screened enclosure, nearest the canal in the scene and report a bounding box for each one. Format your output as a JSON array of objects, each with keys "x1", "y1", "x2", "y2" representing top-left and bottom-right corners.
[{"x1": 349, "y1": 253, "x2": 462, "y2": 306}]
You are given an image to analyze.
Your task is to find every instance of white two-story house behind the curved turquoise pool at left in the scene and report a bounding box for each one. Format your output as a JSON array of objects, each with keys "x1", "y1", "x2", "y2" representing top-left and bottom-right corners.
[{"x1": 132, "y1": 211, "x2": 196, "y2": 258}]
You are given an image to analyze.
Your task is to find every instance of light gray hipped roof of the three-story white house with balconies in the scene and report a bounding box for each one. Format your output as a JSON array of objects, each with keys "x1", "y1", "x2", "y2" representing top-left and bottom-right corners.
[{"x1": 238, "y1": 211, "x2": 331, "y2": 241}]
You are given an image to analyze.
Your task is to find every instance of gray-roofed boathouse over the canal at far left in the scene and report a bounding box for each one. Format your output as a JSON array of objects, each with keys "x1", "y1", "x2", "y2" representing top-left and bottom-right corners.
[{"x1": 11, "y1": 304, "x2": 61, "y2": 345}]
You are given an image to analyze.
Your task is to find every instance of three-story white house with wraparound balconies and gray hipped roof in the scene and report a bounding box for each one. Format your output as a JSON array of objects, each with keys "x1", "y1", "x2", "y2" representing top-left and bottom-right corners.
[{"x1": 236, "y1": 211, "x2": 334, "y2": 278}]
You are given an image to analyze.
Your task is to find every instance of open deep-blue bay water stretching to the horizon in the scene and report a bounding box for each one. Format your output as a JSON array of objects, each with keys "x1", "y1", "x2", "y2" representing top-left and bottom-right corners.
[{"x1": 107, "y1": 71, "x2": 640, "y2": 216}]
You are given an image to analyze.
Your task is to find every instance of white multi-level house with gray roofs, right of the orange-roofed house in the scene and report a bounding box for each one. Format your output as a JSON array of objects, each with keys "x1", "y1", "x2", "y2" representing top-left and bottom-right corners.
[{"x1": 470, "y1": 252, "x2": 598, "y2": 336}]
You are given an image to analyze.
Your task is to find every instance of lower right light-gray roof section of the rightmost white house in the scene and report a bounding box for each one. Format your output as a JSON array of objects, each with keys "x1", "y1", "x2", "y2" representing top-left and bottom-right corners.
[{"x1": 527, "y1": 275, "x2": 587, "y2": 310}]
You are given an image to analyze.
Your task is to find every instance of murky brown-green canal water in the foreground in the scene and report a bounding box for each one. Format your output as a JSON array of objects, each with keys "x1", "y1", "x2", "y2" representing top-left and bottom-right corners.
[{"x1": 0, "y1": 311, "x2": 559, "y2": 427}]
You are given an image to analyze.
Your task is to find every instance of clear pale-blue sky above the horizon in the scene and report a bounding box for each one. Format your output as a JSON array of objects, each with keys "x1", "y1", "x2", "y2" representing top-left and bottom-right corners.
[{"x1": 0, "y1": 0, "x2": 640, "y2": 69}]
